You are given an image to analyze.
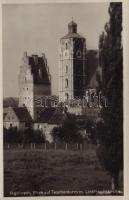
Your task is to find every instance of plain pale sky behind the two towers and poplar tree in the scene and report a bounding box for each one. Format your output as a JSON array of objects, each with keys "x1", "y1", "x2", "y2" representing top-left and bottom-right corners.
[{"x1": 2, "y1": 3, "x2": 109, "y2": 97}]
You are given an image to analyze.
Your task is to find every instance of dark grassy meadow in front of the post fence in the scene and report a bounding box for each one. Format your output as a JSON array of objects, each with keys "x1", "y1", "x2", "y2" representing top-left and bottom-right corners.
[{"x1": 4, "y1": 148, "x2": 122, "y2": 196}]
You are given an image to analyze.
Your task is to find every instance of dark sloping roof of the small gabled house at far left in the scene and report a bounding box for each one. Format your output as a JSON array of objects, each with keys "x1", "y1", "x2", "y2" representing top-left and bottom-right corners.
[{"x1": 13, "y1": 107, "x2": 32, "y2": 122}]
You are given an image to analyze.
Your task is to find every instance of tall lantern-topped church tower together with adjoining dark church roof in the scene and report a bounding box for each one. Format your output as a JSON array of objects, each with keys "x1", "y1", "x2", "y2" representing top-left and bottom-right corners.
[{"x1": 58, "y1": 21, "x2": 99, "y2": 101}]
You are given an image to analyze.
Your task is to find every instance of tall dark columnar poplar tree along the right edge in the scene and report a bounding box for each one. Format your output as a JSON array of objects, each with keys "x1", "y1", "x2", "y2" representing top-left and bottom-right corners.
[{"x1": 96, "y1": 3, "x2": 123, "y2": 190}]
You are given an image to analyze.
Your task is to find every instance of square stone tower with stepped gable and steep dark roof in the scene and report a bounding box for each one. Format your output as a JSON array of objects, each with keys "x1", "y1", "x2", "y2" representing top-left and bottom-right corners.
[{"x1": 18, "y1": 52, "x2": 51, "y2": 120}]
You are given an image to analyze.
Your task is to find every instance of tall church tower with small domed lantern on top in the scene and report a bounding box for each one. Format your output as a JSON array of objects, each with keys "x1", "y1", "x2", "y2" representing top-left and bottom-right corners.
[{"x1": 58, "y1": 20, "x2": 86, "y2": 101}]
